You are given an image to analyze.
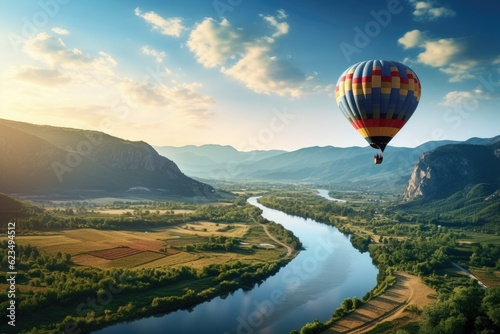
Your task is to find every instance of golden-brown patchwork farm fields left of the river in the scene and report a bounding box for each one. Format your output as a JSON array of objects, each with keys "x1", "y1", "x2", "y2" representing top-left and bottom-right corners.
[{"x1": 17, "y1": 221, "x2": 292, "y2": 269}]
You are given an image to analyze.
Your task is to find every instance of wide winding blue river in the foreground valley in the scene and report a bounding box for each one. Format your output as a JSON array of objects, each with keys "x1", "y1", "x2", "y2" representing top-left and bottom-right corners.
[{"x1": 96, "y1": 193, "x2": 378, "y2": 334}]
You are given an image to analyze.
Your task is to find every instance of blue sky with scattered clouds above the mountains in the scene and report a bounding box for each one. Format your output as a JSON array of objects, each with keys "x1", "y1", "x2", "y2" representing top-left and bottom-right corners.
[{"x1": 0, "y1": 0, "x2": 500, "y2": 151}]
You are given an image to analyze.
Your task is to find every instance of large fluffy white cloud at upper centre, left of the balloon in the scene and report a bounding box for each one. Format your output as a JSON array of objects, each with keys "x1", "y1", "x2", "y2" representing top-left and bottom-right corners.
[{"x1": 187, "y1": 11, "x2": 314, "y2": 97}]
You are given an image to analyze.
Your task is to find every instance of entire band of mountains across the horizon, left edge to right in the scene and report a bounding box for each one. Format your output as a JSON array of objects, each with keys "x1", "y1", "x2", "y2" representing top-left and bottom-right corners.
[{"x1": 0, "y1": 120, "x2": 500, "y2": 200}]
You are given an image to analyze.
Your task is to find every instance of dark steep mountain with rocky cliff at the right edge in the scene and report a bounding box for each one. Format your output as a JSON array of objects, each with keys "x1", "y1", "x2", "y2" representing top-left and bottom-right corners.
[{"x1": 403, "y1": 141, "x2": 500, "y2": 201}]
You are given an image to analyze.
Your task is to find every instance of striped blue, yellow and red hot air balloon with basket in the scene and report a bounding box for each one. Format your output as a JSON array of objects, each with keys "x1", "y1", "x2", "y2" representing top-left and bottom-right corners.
[{"x1": 335, "y1": 60, "x2": 421, "y2": 164}]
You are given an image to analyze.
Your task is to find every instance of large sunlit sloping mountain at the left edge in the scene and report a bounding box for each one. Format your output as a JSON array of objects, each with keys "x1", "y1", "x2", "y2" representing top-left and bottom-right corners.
[{"x1": 0, "y1": 120, "x2": 215, "y2": 196}]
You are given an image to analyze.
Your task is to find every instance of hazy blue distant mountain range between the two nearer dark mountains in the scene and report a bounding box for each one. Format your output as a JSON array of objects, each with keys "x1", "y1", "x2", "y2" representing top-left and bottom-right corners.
[{"x1": 155, "y1": 138, "x2": 500, "y2": 193}]
